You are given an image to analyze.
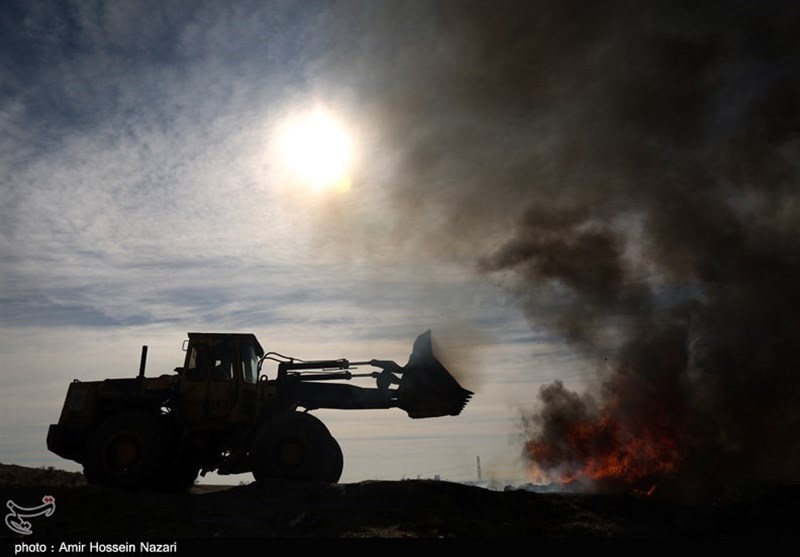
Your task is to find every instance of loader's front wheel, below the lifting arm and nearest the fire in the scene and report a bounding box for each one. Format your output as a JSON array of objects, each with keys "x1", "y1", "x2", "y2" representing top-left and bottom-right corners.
[{"x1": 253, "y1": 412, "x2": 343, "y2": 483}]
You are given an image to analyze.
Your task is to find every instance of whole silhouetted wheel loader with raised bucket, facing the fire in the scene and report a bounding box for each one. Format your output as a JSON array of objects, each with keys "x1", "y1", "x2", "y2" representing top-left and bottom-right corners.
[{"x1": 47, "y1": 331, "x2": 473, "y2": 490}]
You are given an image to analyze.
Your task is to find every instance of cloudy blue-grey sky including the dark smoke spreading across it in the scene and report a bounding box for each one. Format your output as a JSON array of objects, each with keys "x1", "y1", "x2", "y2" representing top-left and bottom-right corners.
[{"x1": 0, "y1": 0, "x2": 800, "y2": 488}]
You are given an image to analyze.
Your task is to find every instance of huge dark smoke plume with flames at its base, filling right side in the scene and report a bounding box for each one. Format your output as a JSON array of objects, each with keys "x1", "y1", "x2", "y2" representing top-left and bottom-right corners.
[{"x1": 322, "y1": 1, "x2": 800, "y2": 487}]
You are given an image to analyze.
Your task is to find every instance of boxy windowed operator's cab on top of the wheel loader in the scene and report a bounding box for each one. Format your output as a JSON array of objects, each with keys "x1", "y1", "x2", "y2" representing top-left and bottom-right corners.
[{"x1": 177, "y1": 333, "x2": 264, "y2": 429}]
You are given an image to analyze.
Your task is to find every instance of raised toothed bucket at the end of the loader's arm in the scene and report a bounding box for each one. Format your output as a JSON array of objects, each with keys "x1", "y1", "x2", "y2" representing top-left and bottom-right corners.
[{"x1": 397, "y1": 331, "x2": 473, "y2": 418}]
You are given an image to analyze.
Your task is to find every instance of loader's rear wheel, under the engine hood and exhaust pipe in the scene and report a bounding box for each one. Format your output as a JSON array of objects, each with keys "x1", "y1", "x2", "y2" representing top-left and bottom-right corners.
[{"x1": 83, "y1": 412, "x2": 174, "y2": 489}]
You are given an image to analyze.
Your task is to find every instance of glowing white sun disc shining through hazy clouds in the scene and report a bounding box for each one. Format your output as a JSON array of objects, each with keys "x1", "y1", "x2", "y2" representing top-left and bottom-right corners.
[{"x1": 281, "y1": 108, "x2": 353, "y2": 191}]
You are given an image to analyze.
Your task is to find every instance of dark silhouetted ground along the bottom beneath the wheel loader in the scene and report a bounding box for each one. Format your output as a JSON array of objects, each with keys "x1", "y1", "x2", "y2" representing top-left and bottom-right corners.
[{"x1": 0, "y1": 464, "x2": 800, "y2": 542}]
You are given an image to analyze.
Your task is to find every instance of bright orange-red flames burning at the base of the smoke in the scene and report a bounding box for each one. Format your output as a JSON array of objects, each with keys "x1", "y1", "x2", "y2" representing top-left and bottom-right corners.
[{"x1": 524, "y1": 402, "x2": 681, "y2": 488}]
